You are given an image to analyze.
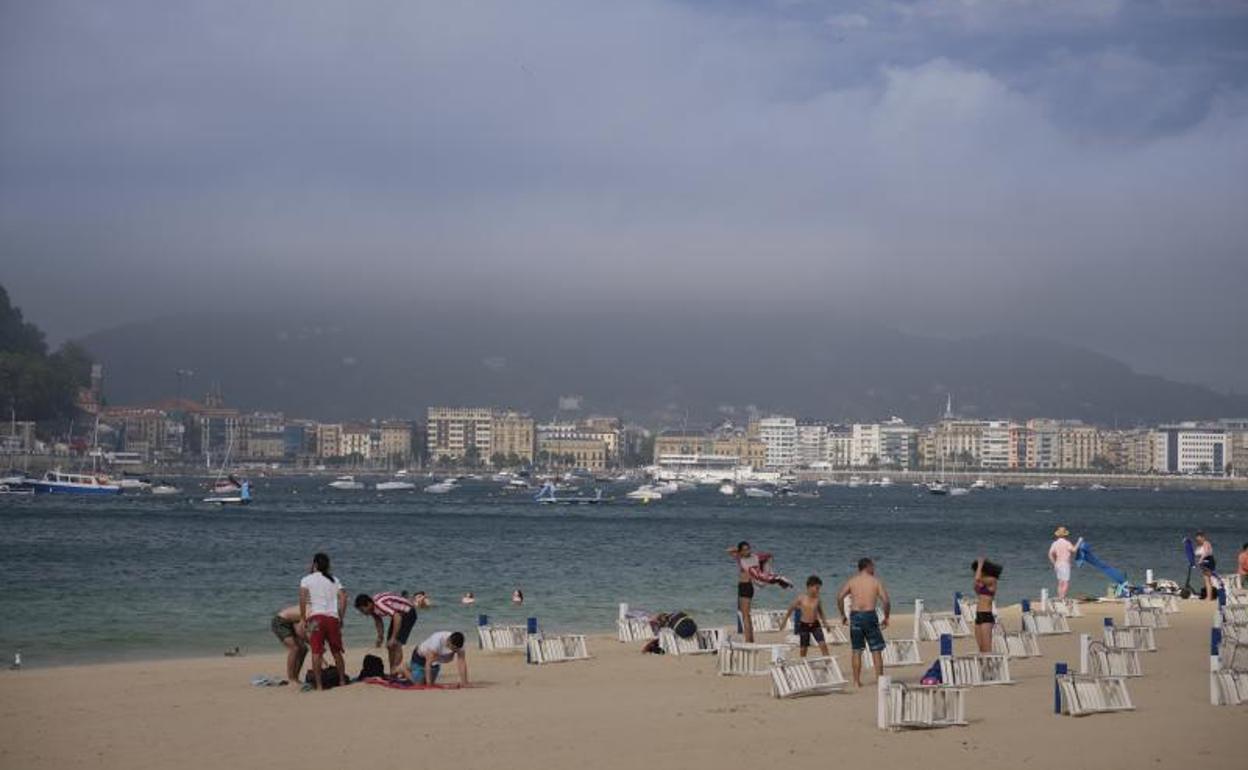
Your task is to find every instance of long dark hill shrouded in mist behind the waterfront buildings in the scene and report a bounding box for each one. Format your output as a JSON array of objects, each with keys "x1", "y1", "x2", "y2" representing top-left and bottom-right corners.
[{"x1": 82, "y1": 306, "x2": 1248, "y2": 426}]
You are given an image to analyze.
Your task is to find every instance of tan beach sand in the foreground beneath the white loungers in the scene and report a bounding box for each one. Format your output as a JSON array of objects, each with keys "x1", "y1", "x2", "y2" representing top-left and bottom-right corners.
[{"x1": 0, "y1": 602, "x2": 1248, "y2": 770}]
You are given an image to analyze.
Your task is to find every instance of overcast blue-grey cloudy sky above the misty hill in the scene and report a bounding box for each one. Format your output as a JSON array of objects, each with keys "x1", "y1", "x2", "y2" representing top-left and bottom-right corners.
[{"x1": 0, "y1": 0, "x2": 1248, "y2": 392}]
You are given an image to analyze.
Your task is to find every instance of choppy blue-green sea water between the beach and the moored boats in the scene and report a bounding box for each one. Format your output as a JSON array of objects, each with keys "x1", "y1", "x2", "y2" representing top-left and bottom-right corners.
[{"x1": 0, "y1": 478, "x2": 1248, "y2": 665}]
